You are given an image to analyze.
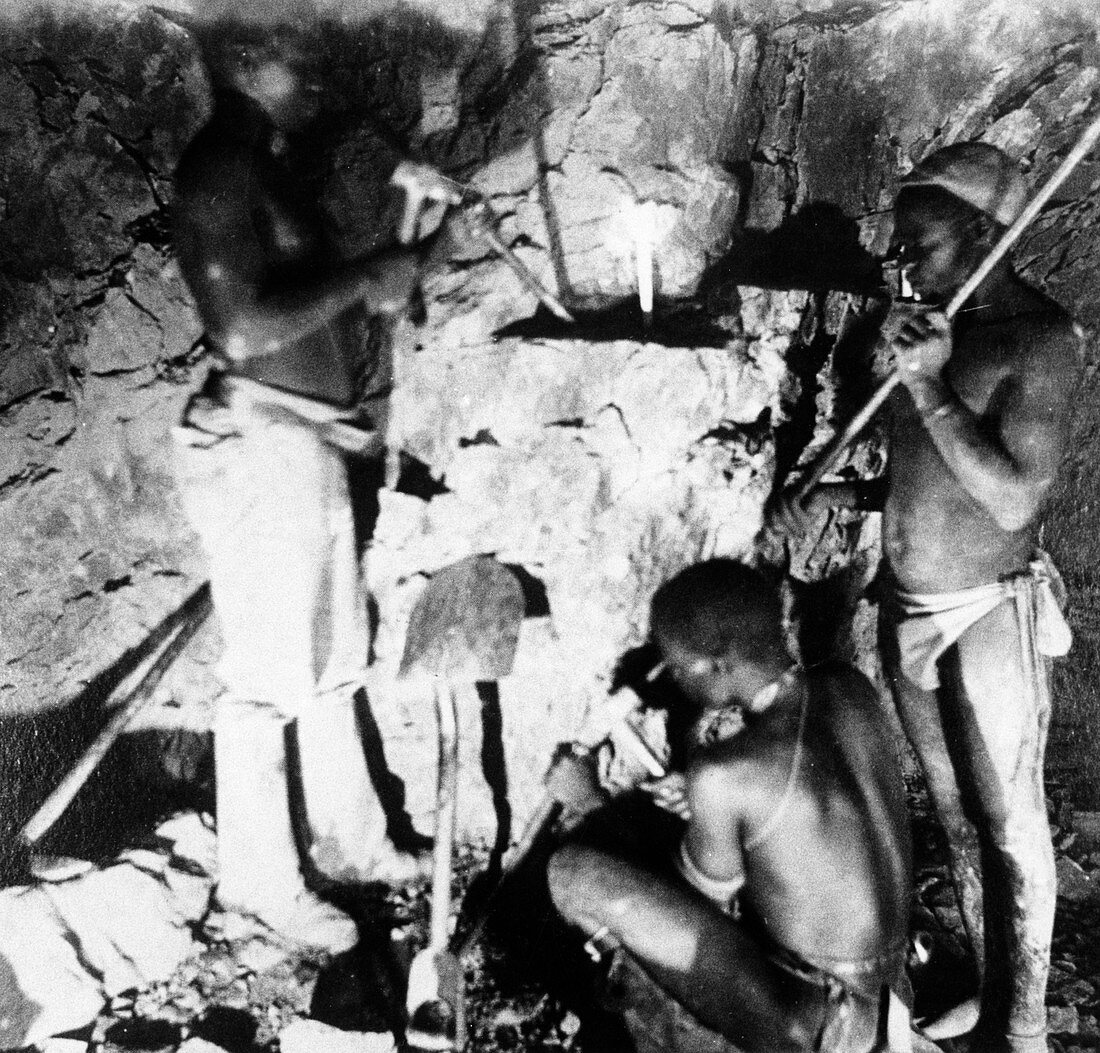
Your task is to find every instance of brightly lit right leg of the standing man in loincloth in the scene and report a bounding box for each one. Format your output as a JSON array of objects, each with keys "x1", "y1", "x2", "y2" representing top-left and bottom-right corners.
[{"x1": 945, "y1": 601, "x2": 1056, "y2": 1053}]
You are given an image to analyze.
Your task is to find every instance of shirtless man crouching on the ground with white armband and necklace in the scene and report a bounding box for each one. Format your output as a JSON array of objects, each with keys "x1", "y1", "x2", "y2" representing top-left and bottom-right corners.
[{"x1": 550, "y1": 559, "x2": 911, "y2": 1053}]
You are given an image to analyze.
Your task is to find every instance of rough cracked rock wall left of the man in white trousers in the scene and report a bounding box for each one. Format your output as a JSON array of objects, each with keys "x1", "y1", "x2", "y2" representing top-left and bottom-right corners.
[{"x1": 0, "y1": 11, "x2": 210, "y2": 712}]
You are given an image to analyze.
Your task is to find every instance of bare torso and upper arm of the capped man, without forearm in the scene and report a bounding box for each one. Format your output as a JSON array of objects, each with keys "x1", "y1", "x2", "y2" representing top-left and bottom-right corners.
[{"x1": 883, "y1": 284, "x2": 1079, "y2": 592}]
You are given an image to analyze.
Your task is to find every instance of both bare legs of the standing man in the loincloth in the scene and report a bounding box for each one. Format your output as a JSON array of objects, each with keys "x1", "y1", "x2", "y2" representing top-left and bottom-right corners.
[{"x1": 881, "y1": 603, "x2": 1055, "y2": 1053}]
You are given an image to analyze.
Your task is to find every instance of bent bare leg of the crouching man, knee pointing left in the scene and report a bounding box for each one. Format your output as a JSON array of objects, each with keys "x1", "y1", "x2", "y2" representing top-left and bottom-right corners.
[{"x1": 549, "y1": 845, "x2": 824, "y2": 1053}]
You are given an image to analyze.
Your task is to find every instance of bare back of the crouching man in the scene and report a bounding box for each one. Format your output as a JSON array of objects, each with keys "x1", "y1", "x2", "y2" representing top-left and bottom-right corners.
[{"x1": 689, "y1": 663, "x2": 911, "y2": 967}]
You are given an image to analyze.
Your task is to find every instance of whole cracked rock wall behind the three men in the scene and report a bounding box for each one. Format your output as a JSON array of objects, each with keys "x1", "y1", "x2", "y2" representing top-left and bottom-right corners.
[{"x1": 0, "y1": 0, "x2": 1100, "y2": 833}]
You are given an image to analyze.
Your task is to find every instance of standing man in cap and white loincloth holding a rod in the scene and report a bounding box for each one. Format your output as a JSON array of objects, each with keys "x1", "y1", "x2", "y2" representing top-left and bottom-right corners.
[{"x1": 788, "y1": 143, "x2": 1081, "y2": 1053}]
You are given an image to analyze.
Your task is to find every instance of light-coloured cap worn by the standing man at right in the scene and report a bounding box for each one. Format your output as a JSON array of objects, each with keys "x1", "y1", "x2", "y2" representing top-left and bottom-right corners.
[{"x1": 901, "y1": 143, "x2": 1027, "y2": 227}]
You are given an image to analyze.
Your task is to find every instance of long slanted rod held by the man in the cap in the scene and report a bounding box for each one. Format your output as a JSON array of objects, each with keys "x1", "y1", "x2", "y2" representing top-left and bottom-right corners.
[{"x1": 795, "y1": 108, "x2": 1100, "y2": 503}]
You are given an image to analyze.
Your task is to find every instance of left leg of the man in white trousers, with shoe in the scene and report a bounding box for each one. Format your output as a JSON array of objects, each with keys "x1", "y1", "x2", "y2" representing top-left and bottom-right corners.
[{"x1": 177, "y1": 410, "x2": 356, "y2": 952}]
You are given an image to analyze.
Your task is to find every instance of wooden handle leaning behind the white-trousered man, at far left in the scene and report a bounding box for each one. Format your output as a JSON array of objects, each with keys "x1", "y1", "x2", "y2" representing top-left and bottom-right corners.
[{"x1": 20, "y1": 584, "x2": 210, "y2": 846}]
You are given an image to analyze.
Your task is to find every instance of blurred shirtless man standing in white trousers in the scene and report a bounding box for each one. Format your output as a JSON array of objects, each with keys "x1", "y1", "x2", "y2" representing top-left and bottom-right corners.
[{"x1": 176, "y1": 12, "x2": 446, "y2": 952}]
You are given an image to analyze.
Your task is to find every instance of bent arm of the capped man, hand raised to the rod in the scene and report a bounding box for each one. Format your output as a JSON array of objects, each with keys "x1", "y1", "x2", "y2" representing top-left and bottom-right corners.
[{"x1": 913, "y1": 321, "x2": 1077, "y2": 530}]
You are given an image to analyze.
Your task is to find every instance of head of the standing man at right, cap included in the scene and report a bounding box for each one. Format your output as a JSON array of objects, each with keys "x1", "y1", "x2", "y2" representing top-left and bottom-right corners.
[{"x1": 893, "y1": 143, "x2": 1027, "y2": 301}]
